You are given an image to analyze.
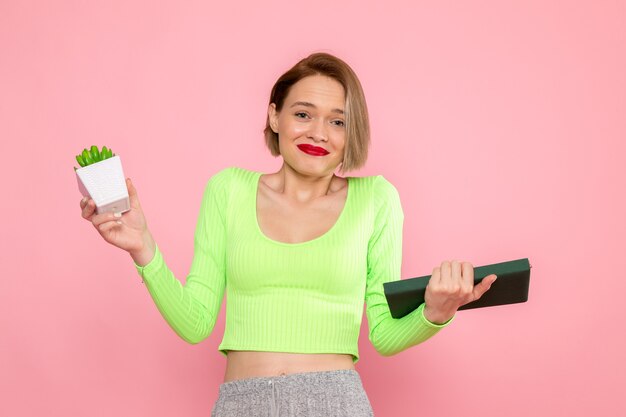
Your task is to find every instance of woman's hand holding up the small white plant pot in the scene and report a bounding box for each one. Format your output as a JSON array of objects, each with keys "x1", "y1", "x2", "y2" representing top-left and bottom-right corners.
[{"x1": 80, "y1": 178, "x2": 152, "y2": 254}]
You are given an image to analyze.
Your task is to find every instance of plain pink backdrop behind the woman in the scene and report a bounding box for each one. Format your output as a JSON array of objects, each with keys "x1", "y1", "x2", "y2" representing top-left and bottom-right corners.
[{"x1": 0, "y1": 0, "x2": 626, "y2": 417}]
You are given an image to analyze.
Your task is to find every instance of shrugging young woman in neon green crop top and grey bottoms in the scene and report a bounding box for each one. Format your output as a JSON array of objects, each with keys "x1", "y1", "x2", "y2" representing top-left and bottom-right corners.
[{"x1": 81, "y1": 53, "x2": 496, "y2": 417}]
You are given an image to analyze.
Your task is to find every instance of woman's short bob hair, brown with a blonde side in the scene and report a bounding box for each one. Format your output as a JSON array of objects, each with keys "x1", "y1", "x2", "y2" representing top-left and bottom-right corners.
[{"x1": 263, "y1": 52, "x2": 370, "y2": 172}]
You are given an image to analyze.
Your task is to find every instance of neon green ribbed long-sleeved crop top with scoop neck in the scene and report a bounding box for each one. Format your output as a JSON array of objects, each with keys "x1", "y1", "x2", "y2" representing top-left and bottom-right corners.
[{"x1": 135, "y1": 167, "x2": 449, "y2": 363}]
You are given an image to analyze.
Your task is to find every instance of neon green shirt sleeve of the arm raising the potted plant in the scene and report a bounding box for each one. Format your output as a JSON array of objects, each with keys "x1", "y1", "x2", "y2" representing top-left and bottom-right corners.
[{"x1": 133, "y1": 170, "x2": 228, "y2": 344}]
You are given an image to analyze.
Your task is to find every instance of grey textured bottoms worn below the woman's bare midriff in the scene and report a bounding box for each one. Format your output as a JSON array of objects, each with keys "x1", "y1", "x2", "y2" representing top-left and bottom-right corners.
[{"x1": 211, "y1": 369, "x2": 374, "y2": 417}]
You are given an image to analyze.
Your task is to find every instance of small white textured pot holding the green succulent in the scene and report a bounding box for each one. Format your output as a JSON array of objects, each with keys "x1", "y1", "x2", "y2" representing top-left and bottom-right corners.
[{"x1": 75, "y1": 155, "x2": 130, "y2": 214}]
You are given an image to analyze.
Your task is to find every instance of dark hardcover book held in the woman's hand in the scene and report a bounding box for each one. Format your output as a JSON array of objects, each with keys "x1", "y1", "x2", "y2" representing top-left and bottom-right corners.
[{"x1": 383, "y1": 258, "x2": 532, "y2": 319}]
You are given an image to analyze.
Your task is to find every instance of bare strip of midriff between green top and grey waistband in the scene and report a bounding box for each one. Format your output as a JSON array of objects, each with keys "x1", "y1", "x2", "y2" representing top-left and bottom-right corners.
[{"x1": 224, "y1": 350, "x2": 354, "y2": 382}]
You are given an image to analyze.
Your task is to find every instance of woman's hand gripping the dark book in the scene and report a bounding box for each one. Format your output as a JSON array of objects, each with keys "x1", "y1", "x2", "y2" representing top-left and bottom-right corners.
[{"x1": 424, "y1": 260, "x2": 497, "y2": 324}]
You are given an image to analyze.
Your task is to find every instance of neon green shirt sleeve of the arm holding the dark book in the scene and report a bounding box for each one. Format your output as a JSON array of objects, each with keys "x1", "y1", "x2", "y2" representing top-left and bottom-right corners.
[{"x1": 365, "y1": 176, "x2": 452, "y2": 356}]
